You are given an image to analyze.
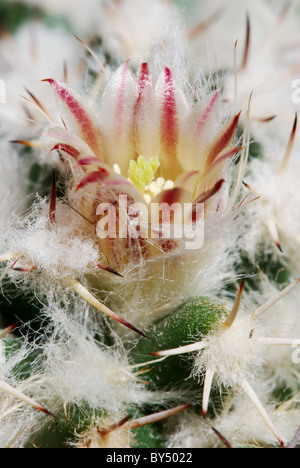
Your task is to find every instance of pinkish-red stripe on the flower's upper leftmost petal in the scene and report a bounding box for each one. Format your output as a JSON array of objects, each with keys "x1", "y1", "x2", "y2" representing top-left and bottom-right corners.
[{"x1": 43, "y1": 79, "x2": 100, "y2": 156}]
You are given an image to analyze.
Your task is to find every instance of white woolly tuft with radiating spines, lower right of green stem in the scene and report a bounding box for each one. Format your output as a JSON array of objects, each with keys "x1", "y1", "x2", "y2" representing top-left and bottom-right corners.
[{"x1": 192, "y1": 278, "x2": 300, "y2": 410}]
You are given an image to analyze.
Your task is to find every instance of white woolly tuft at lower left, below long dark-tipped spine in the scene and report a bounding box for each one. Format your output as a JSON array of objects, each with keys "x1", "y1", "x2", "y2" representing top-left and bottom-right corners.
[{"x1": 36, "y1": 302, "x2": 143, "y2": 413}]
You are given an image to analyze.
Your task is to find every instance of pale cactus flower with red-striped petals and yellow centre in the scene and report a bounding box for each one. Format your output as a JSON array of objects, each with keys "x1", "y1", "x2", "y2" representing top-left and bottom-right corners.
[{"x1": 41, "y1": 63, "x2": 239, "y2": 271}]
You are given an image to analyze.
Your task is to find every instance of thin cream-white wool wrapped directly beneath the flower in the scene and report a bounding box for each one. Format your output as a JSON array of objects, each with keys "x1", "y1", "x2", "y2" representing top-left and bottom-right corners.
[{"x1": 92, "y1": 199, "x2": 238, "y2": 332}]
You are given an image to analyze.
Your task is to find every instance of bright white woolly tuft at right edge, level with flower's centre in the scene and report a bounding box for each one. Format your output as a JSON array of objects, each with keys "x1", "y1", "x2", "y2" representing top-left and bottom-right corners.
[{"x1": 240, "y1": 135, "x2": 300, "y2": 275}]
